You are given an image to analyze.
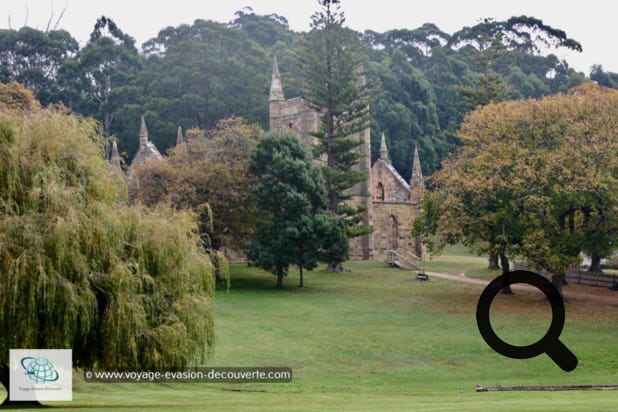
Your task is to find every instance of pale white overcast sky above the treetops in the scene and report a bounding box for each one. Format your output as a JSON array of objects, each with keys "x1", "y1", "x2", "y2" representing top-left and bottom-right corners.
[{"x1": 0, "y1": 0, "x2": 618, "y2": 74}]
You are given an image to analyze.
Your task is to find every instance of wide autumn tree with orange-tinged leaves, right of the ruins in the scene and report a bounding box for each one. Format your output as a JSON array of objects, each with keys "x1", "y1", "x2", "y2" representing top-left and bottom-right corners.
[{"x1": 419, "y1": 84, "x2": 618, "y2": 294}]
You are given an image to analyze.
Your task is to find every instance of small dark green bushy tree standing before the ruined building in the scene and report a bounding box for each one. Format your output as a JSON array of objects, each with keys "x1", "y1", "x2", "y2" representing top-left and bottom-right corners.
[{"x1": 247, "y1": 132, "x2": 347, "y2": 287}]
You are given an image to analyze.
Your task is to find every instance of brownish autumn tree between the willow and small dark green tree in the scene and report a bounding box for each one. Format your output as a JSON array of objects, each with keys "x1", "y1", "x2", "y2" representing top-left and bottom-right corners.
[{"x1": 135, "y1": 117, "x2": 262, "y2": 256}]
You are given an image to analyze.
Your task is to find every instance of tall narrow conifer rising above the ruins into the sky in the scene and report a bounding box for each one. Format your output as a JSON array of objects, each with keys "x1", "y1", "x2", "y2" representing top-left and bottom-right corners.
[{"x1": 298, "y1": 0, "x2": 371, "y2": 268}]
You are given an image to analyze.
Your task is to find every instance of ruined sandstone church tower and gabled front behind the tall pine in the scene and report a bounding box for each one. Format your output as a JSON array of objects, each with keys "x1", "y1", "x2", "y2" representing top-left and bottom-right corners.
[{"x1": 269, "y1": 58, "x2": 424, "y2": 261}]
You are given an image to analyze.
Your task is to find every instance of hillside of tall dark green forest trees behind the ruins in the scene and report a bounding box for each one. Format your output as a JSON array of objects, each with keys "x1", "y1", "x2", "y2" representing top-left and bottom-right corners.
[{"x1": 0, "y1": 8, "x2": 618, "y2": 179}]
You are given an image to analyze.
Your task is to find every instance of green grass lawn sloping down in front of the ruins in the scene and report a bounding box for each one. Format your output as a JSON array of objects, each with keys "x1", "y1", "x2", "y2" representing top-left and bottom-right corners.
[{"x1": 4, "y1": 251, "x2": 618, "y2": 411}]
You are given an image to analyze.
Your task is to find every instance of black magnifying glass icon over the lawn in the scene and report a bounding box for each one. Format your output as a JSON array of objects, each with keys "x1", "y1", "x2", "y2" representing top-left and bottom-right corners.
[{"x1": 476, "y1": 270, "x2": 577, "y2": 372}]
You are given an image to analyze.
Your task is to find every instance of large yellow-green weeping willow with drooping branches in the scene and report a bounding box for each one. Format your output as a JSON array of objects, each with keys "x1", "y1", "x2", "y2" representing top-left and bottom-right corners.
[{"x1": 0, "y1": 94, "x2": 214, "y2": 402}]
